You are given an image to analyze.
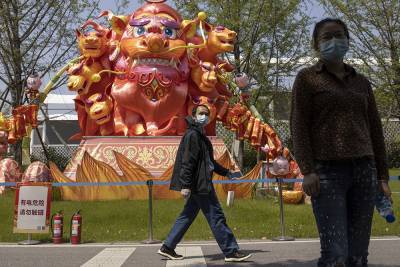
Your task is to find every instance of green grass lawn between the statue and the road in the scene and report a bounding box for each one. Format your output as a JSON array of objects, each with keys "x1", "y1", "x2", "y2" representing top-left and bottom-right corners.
[{"x1": 0, "y1": 181, "x2": 400, "y2": 245}]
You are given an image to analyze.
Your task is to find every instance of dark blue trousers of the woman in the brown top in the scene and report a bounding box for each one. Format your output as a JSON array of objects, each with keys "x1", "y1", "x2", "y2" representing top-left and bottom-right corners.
[{"x1": 311, "y1": 157, "x2": 377, "y2": 266}]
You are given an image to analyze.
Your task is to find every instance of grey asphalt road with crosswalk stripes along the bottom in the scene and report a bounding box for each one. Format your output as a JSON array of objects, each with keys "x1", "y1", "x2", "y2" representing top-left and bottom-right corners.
[{"x1": 0, "y1": 237, "x2": 400, "y2": 267}]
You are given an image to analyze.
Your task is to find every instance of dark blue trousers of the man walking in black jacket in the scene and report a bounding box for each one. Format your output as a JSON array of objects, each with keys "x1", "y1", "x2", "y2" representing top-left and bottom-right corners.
[{"x1": 164, "y1": 189, "x2": 239, "y2": 256}]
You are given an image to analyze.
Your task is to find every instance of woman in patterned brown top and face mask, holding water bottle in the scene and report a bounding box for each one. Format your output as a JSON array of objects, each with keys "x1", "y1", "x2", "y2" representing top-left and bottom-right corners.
[{"x1": 291, "y1": 19, "x2": 390, "y2": 266}]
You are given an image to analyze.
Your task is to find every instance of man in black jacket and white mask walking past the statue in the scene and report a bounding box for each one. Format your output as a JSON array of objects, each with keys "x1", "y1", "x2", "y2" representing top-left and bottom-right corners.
[{"x1": 158, "y1": 105, "x2": 251, "y2": 262}]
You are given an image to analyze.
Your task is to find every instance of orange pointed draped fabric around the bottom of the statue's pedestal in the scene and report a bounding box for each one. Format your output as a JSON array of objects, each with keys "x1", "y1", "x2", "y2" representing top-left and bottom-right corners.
[{"x1": 50, "y1": 151, "x2": 261, "y2": 201}]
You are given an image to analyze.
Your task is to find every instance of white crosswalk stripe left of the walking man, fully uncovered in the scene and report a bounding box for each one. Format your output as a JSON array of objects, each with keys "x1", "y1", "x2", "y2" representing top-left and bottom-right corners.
[{"x1": 81, "y1": 247, "x2": 136, "y2": 267}]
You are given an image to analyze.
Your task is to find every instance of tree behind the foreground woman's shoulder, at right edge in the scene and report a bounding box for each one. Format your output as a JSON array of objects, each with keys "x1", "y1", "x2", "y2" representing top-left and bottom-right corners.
[{"x1": 320, "y1": 0, "x2": 400, "y2": 118}]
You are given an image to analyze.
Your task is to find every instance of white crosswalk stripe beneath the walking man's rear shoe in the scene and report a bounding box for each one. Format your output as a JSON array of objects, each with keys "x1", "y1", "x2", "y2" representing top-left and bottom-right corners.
[{"x1": 166, "y1": 246, "x2": 207, "y2": 267}]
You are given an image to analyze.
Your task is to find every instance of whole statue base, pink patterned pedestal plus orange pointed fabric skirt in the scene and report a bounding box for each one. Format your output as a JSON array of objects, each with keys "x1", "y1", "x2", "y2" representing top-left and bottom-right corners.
[{"x1": 50, "y1": 136, "x2": 261, "y2": 201}]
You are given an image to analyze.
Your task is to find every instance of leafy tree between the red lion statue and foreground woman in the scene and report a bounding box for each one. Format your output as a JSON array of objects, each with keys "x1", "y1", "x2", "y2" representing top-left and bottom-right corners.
[{"x1": 174, "y1": 0, "x2": 311, "y2": 168}]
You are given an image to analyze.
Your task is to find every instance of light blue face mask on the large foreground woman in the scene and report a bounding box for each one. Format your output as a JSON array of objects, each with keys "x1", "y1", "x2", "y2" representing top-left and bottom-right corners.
[{"x1": 319, "y1": 38, "x2": 349, "y2": 61}]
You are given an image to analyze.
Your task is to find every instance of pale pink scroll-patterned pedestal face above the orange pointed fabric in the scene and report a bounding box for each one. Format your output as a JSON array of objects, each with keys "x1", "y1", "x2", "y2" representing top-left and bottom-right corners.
[{"x1": 64, "y1": 136, "x2": 227, "y2": 181}]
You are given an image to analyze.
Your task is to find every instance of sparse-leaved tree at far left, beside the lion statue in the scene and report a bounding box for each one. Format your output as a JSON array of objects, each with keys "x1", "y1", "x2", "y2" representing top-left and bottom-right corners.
[{"x1": 0, "y1": 0, "x2": 98, "y2": 163}]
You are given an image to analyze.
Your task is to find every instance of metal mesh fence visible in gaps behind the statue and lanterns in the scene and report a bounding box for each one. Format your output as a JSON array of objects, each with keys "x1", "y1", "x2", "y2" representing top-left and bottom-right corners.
[{"x1": 31, "y1": 120, "x2": 400, "y2": 171}]
